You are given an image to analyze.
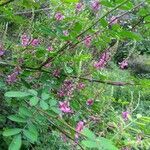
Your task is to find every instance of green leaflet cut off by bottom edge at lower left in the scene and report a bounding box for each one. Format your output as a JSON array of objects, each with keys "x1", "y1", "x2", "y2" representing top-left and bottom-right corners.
[{"x1": 8, "y1": 134, "x2": 22, "y2": 150}]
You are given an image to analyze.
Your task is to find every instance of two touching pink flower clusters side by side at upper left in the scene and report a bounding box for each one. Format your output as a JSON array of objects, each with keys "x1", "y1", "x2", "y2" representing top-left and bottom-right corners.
[{"x1": 21, "y1": 33, "x2": 40, "y2": 47}]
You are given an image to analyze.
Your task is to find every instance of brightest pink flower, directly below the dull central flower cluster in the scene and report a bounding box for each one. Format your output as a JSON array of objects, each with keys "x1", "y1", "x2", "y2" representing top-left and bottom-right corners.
[{"x1": 59, "y1": 101, "x2": 72, "y2": 113}]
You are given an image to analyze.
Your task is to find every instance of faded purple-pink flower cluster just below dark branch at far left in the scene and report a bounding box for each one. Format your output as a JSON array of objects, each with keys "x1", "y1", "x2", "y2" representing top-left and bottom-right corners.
[{"x1": 6, "y1": 67, "x2": 21, "y2": 84}]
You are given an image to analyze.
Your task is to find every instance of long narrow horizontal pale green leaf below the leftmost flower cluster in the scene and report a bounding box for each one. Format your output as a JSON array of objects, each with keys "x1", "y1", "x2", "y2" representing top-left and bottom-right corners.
[{"x1": 5, "y1": 91, "x2": 31, "y2": 98}]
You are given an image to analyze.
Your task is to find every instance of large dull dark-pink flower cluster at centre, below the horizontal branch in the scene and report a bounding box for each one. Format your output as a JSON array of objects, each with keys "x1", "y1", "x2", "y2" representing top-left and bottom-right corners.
[{"x1": 57, "y1": 80, "x2": 75, "y2": 98}]
